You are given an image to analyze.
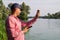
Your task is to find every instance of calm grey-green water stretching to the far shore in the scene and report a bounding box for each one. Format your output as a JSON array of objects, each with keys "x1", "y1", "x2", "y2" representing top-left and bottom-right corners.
[{"x1": 25, "y1": 19, "x2": 60, "y2": 40}]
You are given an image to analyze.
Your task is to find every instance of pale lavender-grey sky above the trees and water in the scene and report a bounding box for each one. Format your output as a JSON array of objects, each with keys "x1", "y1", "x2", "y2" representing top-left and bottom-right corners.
[{"x1": 3, "y1": 0, "x2": 60, "y2": 16}]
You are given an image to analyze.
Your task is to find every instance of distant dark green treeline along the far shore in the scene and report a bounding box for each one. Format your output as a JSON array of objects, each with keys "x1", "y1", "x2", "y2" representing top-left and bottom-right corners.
[{"x1": 28, "y1": 11, "x2": 60, "y2": 19}]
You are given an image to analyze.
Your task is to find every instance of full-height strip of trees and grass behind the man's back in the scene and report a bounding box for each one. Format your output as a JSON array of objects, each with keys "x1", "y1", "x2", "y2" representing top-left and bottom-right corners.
[{"x1": 0, "y1": 0, "x2": 10, "y2": 40}]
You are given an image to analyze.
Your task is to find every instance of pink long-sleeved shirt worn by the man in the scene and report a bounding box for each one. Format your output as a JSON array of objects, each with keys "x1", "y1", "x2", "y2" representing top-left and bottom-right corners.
[{"x1": 6, "y1": 15, "x2": 37, "y2": 40}]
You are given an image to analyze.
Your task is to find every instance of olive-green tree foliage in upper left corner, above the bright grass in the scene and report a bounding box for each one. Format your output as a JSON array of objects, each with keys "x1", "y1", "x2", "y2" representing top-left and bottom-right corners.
[{"x1": 0, "y1": 0, "x2": 9, "y2": 20}]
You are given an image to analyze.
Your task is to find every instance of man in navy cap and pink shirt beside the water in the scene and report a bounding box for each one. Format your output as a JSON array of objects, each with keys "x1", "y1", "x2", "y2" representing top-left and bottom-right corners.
[{"x1": 6, "y1": 3, "x2": 40, "y2": 40}]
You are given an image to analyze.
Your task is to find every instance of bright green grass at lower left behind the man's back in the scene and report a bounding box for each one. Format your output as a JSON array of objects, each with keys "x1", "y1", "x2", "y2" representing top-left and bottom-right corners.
[{"x1": 0, "y1": 20, "x2": 7, "y2": 40}]
